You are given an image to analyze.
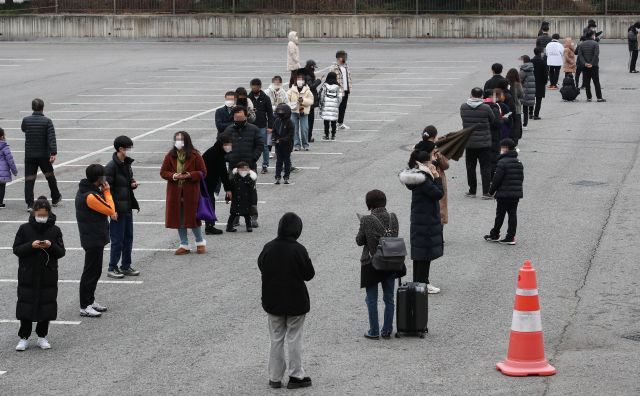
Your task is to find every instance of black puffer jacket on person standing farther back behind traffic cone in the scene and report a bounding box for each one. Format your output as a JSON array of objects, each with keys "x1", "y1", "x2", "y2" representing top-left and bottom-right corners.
[{"x1": 489, "y1": 150, "x2": 524, "y2": 200}]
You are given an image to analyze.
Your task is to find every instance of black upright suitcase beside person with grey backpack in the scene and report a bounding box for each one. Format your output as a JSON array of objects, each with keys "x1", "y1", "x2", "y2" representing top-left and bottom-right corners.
[{"x1": 396, "y1": 279, "x2": 429, "y2": 338}]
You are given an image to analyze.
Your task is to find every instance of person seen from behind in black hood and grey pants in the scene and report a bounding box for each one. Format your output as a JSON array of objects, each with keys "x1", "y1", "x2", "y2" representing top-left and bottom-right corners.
[{"x1": 258, "y1": 212, "x2": 315, "y2": 389}]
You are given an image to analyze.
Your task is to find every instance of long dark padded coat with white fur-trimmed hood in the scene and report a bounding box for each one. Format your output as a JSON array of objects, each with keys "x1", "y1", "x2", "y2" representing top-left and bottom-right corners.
[{"x1": 400, "y1": 169, "x2": 444, "y2": 260}]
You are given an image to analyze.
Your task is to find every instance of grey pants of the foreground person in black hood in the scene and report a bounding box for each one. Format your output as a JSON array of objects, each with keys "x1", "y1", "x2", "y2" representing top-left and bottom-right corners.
[{"x1": 269, "y1": 314, "x2": 305, "y2": 382}]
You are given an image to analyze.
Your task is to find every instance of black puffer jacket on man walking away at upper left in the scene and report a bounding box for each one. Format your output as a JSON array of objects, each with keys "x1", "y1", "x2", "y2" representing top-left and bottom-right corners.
[{"x1": 22, "y1": 111, "x2": 58, "y2": 158}]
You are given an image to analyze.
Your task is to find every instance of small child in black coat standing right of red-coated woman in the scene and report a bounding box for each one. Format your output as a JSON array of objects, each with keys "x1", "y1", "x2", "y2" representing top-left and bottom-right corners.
[{"x1": 227, "y1": 162, "x2": 258, "y2": 232}]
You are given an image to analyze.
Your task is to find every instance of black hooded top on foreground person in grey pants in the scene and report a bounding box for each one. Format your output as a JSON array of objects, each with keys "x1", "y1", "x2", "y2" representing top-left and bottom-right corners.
[{"x1": 258, "y1": 213, "x2": 315, "y2": 316}]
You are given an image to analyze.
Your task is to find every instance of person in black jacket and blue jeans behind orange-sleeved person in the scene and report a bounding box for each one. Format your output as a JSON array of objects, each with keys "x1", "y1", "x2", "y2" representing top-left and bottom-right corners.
[{"x1": 105, "y1": 136, "x2": 140, "y2": 279}]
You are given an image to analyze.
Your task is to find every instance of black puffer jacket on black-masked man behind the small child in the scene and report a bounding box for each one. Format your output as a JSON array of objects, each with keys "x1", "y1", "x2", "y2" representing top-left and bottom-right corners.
[{"x1": 224, "y1": 122, "x2": 264, "y2": 170}]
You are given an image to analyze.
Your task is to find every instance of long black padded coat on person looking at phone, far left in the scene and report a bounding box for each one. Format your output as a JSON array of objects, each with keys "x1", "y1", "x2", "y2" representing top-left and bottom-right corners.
[{"x1": 13, "y1": 214, "x2": 65, "y2": 322}]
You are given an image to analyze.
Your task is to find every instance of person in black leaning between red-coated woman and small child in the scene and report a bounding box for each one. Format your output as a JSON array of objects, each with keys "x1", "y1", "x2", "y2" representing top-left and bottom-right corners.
[{"x1": 202, "y1": 135, "x2": 233, "y2": 235}]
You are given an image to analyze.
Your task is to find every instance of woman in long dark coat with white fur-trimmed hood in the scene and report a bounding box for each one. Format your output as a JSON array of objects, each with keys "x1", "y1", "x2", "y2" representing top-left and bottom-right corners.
[{"x1": 399, "y1": 150, "x2": 444, "y2": 294}]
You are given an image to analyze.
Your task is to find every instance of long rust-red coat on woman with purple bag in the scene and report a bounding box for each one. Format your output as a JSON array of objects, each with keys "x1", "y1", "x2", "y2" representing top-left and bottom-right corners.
[{"x1": 160, "y1": 151, "x2": 207, "y2": 229}]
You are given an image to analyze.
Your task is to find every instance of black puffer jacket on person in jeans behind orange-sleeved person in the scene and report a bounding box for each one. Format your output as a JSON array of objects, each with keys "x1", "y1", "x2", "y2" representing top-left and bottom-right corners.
[{"x1": 104, "y1": 153, "x2": 140, "y2": 215}]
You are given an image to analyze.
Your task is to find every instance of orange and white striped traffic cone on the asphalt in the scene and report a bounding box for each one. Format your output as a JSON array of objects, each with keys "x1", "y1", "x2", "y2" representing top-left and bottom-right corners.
[{"x1": 496, "y1": 260, "x2": 556, "y2": 377}]
